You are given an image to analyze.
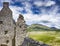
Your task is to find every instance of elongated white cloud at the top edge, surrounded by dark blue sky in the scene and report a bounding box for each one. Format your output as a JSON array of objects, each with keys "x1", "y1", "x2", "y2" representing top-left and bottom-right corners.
[{"x1": 34, "y1": 0, "x2": 56, "y2": 6}]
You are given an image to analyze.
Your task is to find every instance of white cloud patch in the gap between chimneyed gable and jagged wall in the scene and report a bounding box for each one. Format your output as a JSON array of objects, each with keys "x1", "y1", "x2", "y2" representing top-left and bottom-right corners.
[{"x1": 10, "y1": 6, "x2": 23, "y2": 21}]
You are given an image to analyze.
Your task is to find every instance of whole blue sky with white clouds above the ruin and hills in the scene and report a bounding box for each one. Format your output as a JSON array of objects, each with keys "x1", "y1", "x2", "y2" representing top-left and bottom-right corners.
[{"x1": 0, "y1": 0, "x2": 60, "y2": 28}]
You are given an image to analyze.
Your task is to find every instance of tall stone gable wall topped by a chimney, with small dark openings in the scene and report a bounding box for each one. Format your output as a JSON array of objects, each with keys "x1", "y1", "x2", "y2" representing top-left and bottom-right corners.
[{"x1": 0, "y1": 2, "x2": 14, "y2": 46}]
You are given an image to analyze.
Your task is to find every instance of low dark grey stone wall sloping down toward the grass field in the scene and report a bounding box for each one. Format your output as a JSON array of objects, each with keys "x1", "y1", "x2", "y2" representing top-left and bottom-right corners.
[{"x1": 21, "y1": 37, "x2": 50, "y2": 46}]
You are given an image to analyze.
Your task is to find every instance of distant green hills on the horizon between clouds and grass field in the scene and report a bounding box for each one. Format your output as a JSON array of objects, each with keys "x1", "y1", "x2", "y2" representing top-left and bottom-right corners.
[{"x1": 27, "y1": 24, "x2": 60, "y2": 31}]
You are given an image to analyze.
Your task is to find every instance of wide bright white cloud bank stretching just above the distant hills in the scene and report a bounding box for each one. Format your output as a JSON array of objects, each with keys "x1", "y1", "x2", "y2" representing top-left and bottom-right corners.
[{"x1": 23, "y1": 14, "x2": 60, "y2": 28}]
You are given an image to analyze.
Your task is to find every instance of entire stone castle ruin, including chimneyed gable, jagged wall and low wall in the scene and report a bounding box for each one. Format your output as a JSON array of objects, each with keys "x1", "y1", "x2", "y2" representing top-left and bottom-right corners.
[{"x1": 0, "y1": 2, "x2": 48, "y2": 46}]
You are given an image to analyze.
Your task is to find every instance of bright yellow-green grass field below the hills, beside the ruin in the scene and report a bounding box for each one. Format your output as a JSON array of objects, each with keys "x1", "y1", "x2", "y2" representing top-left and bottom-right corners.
[{"x1": 28, "y1": 31, "x2": 60, "y2": 46}]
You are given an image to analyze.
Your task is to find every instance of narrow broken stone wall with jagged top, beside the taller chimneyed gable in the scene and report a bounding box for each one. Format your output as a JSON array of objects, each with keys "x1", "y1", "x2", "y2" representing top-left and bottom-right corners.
[{"x1": 15, "y1": 15, "x2": 26, "y2": 46}]
